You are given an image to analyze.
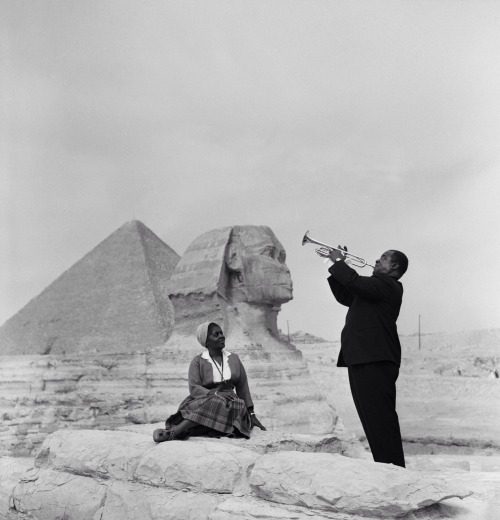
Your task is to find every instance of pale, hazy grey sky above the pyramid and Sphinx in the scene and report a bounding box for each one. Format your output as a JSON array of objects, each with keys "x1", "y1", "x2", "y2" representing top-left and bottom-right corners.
[{"x1": 0, "y1": 0, "x2": 500, "y2": 339}]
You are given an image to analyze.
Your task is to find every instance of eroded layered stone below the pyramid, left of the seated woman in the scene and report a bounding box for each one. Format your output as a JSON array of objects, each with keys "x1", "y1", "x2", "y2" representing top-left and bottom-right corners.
[{"x1": 0, "y1": 348, "x2": 209, "y2": 456}]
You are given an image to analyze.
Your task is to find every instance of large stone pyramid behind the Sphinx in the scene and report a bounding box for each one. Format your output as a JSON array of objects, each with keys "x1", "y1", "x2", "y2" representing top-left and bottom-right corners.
[{"x1": 0, "y1": 220, "x2": 180, "y2": 355}]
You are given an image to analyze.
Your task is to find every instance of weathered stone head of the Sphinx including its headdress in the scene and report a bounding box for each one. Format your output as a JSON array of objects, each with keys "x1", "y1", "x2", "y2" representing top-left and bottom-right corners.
[{"x1": 169, "y1": 226, "x2": 292, "y2": 334}]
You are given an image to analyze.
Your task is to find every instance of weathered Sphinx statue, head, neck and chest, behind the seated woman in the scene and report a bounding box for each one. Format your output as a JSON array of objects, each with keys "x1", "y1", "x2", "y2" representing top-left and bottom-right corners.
[{"x1": 165, "y1": 226, "x2": 341, "y2": 434}]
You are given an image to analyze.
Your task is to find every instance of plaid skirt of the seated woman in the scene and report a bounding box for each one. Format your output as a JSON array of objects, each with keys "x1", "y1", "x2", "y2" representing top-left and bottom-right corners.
[{"x1": 166, "y1": 394, "x2": 251, "y2": 439}]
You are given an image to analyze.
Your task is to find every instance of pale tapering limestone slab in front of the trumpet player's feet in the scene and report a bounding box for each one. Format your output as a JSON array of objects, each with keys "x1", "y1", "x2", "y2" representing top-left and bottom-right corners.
[{"x1": 250, "y1": 452, "x2": 470, "y2": 518}]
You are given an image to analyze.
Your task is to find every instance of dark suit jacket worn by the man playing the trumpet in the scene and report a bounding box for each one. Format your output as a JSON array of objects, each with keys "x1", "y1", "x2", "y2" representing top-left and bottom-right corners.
[{"x1": 328, "y1": 262, "x2": 403, "y2": 367}]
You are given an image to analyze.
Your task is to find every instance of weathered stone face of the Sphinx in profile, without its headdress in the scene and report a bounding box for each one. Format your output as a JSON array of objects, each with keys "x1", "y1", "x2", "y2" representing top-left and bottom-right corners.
[{"x1": 226, "y1": 226, "x2": 293, "y2": 305}]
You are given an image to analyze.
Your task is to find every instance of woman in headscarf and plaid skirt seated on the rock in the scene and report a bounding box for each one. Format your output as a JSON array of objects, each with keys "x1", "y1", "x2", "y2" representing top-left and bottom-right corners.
[{"x1": 153, "y1": 321, "x2": 265, "y2": 442}]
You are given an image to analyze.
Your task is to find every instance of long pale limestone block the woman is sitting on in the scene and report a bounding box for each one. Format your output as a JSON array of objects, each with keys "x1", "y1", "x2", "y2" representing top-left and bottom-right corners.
[{"x1": 35, "y1": 430, "x2": 258, "y2": 494}]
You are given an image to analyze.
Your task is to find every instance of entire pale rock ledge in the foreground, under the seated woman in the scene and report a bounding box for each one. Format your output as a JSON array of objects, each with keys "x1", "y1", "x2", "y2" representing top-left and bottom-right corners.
[{"x1": 0, "y1": 431, "x2": 470, "y2": 520}]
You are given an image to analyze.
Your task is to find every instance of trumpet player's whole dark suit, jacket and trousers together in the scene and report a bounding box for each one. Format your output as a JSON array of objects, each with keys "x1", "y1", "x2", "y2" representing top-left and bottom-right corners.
[{"x1": 328, "y1": 261, "x2": 405, "y2": 467}]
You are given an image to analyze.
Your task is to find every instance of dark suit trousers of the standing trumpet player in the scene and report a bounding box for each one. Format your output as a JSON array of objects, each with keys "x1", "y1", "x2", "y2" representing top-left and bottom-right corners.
[{"x1": 348, "y1": 361, "x2": 405, "y2": 468}]
